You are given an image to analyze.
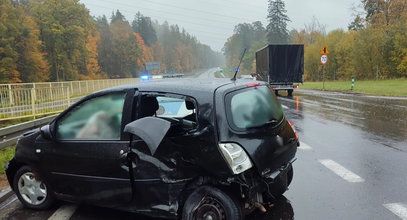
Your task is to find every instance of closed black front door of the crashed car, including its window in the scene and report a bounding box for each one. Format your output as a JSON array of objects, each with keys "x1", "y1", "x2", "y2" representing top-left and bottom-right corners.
[{"x1": 36, "y1": 91, "x2": 134, "y2": 206}]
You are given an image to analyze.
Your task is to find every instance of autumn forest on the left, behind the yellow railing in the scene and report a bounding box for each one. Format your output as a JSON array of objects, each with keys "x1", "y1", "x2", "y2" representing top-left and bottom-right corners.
[{"x1": 0, "y1": 0, "x2": 223, "y2": 83}]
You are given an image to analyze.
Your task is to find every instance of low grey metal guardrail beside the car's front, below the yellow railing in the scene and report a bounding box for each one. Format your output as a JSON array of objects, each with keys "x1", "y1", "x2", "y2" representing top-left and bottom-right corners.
[{"x1": 0, "y1": 115, "x2": 56, "y2": 150}]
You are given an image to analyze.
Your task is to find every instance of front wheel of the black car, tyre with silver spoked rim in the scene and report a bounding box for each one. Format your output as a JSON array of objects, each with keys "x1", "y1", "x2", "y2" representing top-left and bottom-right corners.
[{"x1": 13, "y1": 166, "x2": 54, "y2": 210}]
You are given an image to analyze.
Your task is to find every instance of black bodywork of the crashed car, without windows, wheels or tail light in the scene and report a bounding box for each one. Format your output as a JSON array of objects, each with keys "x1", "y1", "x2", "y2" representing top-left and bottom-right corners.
[{"x1": 7, "y1": 79, "x2": 298, "y2": 217}]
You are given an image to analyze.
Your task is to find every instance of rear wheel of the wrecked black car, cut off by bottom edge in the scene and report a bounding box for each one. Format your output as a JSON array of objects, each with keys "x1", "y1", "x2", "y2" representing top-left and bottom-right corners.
[{"x1": 182, "y1": 186, "x2": 244, "y2": 220}]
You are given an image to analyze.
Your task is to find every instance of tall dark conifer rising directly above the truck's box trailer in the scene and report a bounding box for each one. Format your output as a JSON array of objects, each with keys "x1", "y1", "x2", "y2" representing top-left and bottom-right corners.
[{"x1": 267, "y1": 0, "x2": 290, "y2": 44}]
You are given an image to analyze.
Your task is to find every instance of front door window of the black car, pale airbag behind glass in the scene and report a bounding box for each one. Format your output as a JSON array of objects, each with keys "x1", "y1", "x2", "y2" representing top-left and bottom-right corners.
[{"x1": 56, "y1": 93, "x2": 125, "y2": 140}]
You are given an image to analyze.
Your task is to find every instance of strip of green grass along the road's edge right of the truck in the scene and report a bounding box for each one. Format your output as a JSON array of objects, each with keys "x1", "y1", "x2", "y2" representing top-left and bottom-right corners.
[{"x1": 300, "y1": 79, "x2": 407, "y2": 96}]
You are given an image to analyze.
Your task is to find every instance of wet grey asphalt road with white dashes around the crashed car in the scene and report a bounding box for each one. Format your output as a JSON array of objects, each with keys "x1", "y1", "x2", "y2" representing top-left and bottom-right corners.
[{"x1": 0, "y1": 84, "x2": 407, "y2": 220}]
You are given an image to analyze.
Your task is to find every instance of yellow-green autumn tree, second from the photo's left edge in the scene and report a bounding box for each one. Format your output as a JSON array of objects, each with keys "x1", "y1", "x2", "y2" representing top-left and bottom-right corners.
[{"x1": 30, "y1": 0, "x2": 93, "y2": 81}]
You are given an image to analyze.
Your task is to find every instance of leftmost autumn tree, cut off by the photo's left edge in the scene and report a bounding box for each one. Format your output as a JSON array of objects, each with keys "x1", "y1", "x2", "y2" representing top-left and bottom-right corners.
[{"x1": 0, "y1": 0, "x2": 48, "y2": 82}]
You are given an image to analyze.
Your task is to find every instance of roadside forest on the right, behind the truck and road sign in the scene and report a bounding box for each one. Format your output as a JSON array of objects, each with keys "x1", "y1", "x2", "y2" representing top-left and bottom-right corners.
[{"x1": 223, "y1": 0, "x2": 407, "y2": 81}]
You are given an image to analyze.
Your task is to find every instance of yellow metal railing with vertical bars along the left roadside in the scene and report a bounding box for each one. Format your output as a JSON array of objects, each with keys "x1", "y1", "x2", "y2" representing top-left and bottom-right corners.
[{"x1": 0, "y1": 78, "x2": 140, "y2": 121}]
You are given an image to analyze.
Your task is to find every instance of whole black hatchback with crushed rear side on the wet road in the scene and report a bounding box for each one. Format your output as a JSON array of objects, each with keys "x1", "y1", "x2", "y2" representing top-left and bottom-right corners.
[{"x1": 6, "y1": 79, "x2": 299, "y2": 220}]
